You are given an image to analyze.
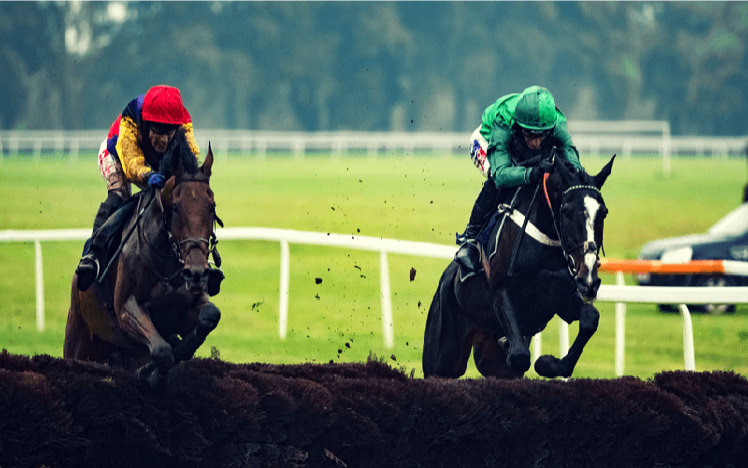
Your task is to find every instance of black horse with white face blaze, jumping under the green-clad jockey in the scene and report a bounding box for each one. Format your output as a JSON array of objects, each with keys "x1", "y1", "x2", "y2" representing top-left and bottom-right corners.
[{"x1": 423, "y1": 156, "x2": 615, "y2": 378}]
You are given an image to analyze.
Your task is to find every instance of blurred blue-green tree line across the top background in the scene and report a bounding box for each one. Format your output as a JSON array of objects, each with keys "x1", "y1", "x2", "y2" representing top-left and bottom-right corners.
[{"x1": 0, "y1": 0, "x2": 748, "y2": 135}]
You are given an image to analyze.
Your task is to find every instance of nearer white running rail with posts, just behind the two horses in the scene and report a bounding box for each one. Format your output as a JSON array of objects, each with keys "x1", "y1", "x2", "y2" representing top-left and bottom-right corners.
[{"x1": 0, "y1": 227, "x2": 748, "y2": 375}]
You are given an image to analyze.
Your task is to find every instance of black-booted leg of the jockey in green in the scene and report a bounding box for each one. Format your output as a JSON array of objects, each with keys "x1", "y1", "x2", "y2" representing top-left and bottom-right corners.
[{"x1": 455, "y1": 179, "x2": 499, "y2": 278}]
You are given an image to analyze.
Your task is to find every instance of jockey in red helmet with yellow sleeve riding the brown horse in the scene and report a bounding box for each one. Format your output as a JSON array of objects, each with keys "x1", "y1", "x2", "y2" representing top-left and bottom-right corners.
[{"x1": 75, "y1": 85, "x2": 200, "y2": 291}]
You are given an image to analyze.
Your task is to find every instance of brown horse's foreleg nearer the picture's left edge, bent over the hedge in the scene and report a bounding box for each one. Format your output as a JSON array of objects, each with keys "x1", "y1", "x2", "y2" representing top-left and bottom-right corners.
[{"x1": 118, "y1": 296, "x2": 174, "y2": 382}]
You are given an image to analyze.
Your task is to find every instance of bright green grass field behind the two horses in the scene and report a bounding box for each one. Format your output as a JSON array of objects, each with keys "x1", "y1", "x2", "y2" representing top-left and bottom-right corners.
[{"x1": 0, "y1": 154, "x2": 748, "y2": 378}]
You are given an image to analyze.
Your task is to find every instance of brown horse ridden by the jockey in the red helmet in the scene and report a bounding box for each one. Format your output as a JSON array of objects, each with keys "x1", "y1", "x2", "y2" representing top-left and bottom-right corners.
[{"x1": 63, "y1": 134, "x2": 222, "y2": 387}]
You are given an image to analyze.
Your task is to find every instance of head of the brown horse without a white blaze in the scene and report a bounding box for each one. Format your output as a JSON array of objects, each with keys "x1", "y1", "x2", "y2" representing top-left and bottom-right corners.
[{"x1": 161, "y1": 146, "x2": 218, "y2": 294}]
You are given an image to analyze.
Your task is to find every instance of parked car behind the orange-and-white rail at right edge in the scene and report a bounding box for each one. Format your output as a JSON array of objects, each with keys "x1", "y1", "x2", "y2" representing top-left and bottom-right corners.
[{"x1": 637, "y1": 203, "x2": 748, "y2": 314}]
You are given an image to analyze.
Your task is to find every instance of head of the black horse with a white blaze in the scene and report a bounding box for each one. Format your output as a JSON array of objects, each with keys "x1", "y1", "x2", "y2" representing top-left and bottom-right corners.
[{"x1": 546, "y1": 155, "x2": 615, "y2": 300}]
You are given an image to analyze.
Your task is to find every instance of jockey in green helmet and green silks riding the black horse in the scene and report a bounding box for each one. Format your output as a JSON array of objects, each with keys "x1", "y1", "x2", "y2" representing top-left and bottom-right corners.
[{"x1": 455, "y1": 86, "x2": 582, "y2": 279}]
